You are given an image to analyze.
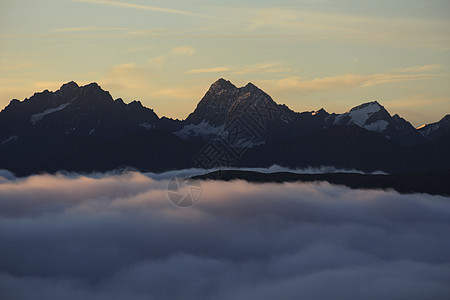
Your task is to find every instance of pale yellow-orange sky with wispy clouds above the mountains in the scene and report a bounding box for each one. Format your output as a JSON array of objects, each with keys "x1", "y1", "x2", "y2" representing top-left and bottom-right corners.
[{"x1": 0, "y1": 0, "x2": 450, "y2": 126}]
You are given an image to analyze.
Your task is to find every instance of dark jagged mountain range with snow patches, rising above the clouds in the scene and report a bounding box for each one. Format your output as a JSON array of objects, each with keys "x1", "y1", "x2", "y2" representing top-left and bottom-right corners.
[{"x1": 0, "y1": 79, "x2": 450, "y2": 175}]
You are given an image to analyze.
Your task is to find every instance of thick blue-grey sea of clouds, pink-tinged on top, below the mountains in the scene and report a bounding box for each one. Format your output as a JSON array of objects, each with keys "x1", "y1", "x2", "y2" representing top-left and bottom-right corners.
[{"x1": 0, "y1": 170, "x2": 450, "y2": 300}]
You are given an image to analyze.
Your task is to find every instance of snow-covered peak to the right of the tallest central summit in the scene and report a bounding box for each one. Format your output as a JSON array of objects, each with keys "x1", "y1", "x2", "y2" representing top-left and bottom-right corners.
[{"x1": 333, "y1": 101, "x2": 389, "y2": 132}]
